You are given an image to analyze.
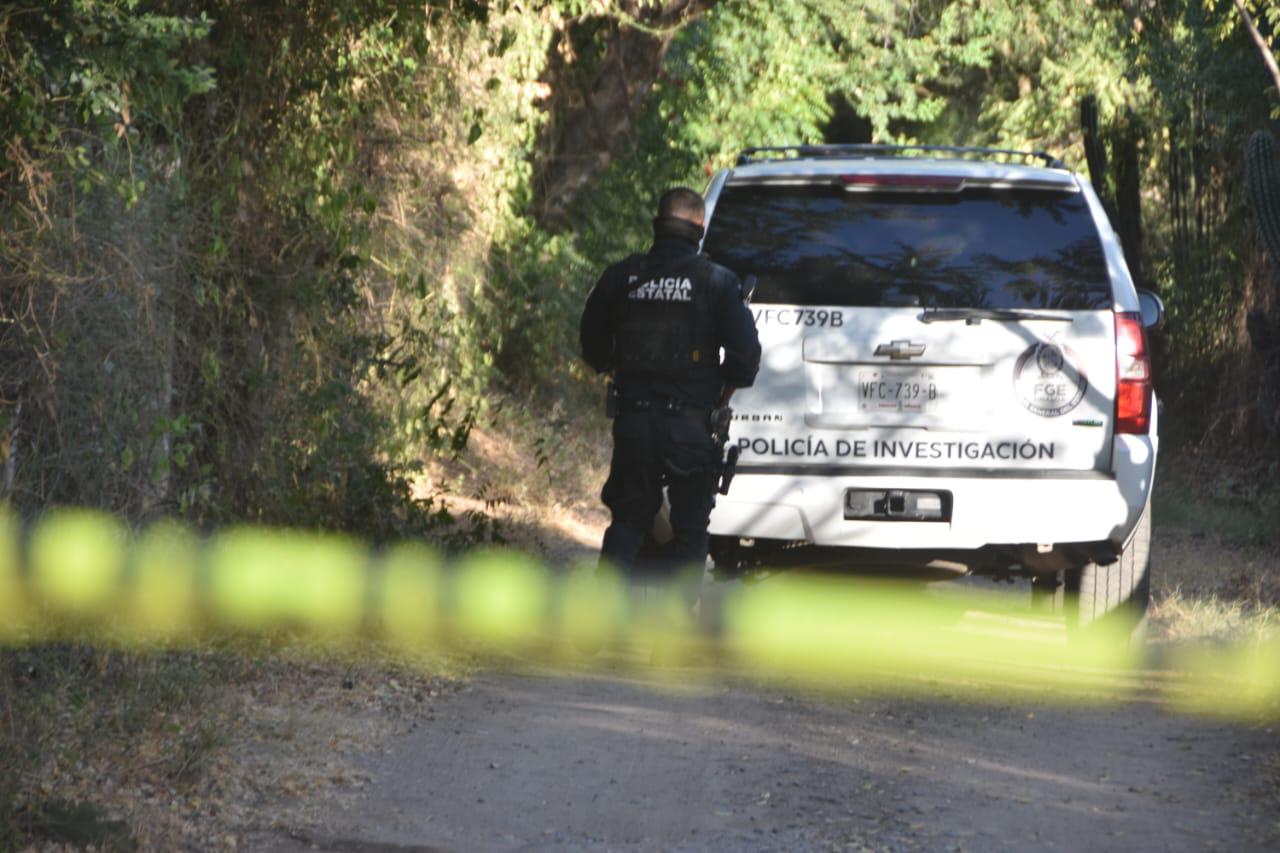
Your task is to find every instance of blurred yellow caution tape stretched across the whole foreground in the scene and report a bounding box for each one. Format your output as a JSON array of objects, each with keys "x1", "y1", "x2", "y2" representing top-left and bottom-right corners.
[{"x1": 0, "y1": 510, "x2": 1280, "y2": 716}]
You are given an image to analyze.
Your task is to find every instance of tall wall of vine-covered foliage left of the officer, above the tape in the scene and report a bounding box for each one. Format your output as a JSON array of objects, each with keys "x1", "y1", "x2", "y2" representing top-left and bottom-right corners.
[{"x1": 0, "y1": 0, "x2": 538, "y2": 537}]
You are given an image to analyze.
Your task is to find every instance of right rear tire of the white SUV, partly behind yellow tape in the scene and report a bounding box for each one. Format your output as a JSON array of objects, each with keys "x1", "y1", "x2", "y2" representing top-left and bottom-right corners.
[{"x1": 1066, "y1": 498, "x2": 1151, "y2": 646}]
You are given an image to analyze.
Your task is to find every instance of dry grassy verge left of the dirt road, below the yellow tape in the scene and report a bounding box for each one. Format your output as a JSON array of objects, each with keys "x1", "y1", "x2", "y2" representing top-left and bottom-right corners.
[{"x1": 0, "y1": 637, "x2": 458, "y2": 850}]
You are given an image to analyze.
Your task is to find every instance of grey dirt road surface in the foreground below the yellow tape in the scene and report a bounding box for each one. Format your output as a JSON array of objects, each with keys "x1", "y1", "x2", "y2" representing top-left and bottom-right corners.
[{"x1": 253, "y1": 653, "x2": 1280, "y2": 852}]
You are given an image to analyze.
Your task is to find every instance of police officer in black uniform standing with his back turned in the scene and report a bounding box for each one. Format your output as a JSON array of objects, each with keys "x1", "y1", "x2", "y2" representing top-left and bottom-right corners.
[{"x1": 581, "y1": 187, "x2": 760, "y2": 571}]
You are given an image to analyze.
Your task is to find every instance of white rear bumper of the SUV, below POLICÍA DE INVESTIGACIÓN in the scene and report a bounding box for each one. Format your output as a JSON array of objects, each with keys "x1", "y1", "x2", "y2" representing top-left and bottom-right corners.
[{"x1": 710, "y1": 435, "x2": 1156, "y2": 551}]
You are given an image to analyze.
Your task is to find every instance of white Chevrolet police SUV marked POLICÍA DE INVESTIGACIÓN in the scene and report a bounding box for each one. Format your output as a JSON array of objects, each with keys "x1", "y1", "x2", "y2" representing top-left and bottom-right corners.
[{"x1": 703, "y1": 146, "x2": 1164, "y2": 635}]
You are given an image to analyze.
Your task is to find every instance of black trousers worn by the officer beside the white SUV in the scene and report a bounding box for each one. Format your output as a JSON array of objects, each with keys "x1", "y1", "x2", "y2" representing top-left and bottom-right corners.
[{"x1": 600, "y1": 409, "x2": 719, "y2": 575}]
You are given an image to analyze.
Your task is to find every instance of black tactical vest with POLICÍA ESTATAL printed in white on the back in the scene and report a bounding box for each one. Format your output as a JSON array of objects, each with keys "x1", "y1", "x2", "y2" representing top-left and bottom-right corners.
[{"x1": 613, "y1": 247, "x2": 719, "y2": 382}]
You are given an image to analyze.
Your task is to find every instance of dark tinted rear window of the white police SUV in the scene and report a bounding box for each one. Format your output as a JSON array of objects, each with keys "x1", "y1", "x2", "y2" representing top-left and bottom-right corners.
[{"x1": 703, "y1": 184, "x2": 1111, "y2": 310}]
